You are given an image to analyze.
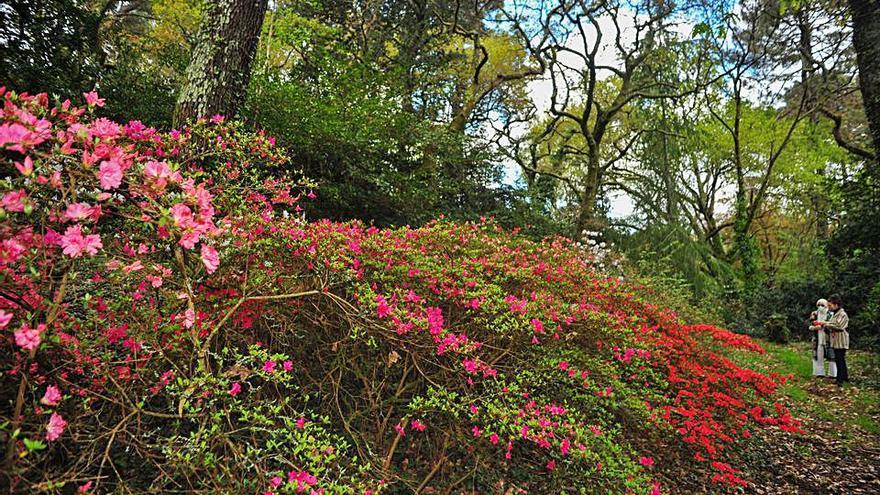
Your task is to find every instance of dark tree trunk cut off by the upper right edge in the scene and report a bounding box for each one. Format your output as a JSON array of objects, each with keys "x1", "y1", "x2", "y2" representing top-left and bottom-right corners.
[{"x1": 849, "y1": 0, "x2": 880, "y2": 165}]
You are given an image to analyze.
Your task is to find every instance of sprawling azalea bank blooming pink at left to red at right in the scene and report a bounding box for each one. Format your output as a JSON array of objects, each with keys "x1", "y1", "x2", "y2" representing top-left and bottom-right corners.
[{"x1": 0, "y1": 92, "x2": 798, "y2": 495}]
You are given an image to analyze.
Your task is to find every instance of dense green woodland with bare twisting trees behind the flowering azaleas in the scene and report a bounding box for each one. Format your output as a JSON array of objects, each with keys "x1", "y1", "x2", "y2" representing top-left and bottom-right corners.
[{"x1": 0, "y1": 0, "x2": 880, "y2": 346}]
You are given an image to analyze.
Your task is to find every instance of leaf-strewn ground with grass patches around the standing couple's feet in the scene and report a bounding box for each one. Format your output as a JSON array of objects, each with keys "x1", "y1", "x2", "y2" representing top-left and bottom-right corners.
[{"x1": 724, "y1": 342, "x2": 880, "y2": 495}]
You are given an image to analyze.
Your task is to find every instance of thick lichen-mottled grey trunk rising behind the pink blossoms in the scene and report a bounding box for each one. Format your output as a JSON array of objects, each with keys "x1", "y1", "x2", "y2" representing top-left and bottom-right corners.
[{"x1": 174, "y1": 0, "x2": 268, "y2": 125}]
